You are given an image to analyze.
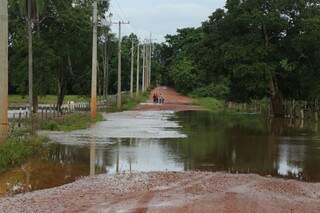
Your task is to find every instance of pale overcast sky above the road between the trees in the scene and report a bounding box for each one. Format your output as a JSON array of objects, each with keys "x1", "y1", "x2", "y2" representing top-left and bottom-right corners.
[{"x1": 110, "y1": 0, "x2": 225, "y2": 42}]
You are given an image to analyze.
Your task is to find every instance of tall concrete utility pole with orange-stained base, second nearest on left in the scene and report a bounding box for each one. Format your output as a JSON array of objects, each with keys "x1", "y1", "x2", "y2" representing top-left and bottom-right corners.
[{"x1": 90, "y1": 0, "x2": 98, "y2": 119}]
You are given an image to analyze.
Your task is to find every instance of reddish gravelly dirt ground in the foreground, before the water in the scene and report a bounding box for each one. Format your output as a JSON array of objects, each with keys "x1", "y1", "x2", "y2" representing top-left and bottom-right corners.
[{"x1": 0, "y1": 172, "x2": 320, "y2": 213}]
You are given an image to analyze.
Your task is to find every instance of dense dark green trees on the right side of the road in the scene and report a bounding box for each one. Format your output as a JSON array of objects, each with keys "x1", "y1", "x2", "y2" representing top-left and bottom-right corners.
[{"x1": 154, "y1": 0, "x2": 320, "y2": 116}]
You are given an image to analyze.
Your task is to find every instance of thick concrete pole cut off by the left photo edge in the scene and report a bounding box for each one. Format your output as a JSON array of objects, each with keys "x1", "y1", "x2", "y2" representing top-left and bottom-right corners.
[{"x1": 0, "y1": 0, "x2": 9, "y2": 143}]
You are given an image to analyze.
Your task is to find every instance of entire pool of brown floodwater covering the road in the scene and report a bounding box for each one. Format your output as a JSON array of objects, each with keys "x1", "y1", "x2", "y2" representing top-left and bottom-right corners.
[{"x1": 0, "y1": 111, "x2": 320, "y2": 196}]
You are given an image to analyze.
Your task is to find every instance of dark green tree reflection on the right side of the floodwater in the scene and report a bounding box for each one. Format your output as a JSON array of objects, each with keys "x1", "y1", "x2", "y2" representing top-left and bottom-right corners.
[{"x1": 167, "y1": 112, "x2": 320, "y2": 180}]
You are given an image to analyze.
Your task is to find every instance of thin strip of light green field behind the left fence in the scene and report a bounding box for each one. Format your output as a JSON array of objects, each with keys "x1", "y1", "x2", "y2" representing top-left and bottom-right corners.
[{"x1": 9, "y1": 95, "x2": 89, "y2": 105}]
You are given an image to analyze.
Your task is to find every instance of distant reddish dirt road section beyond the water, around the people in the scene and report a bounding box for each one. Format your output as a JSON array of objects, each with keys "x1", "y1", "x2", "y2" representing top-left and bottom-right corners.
[{"x1": 135, "y1": 87, "x2": 201, "y2": 111}]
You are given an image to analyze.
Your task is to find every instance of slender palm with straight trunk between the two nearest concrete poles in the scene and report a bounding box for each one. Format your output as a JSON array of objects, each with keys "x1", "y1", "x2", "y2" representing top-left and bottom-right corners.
[{"x1": 19, "y1": 0, "x2": 46, "y2": 113}]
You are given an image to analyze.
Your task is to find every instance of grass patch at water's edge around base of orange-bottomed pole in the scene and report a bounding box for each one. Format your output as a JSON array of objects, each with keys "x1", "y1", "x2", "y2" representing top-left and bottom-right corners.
[{"x1": 39, "y1": 113, "x2": 103, "y2": 132}]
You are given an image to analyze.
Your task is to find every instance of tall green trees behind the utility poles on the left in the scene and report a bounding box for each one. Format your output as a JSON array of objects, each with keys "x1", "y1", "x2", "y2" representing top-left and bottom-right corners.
[{"x1": 8, "y1": 0, "x2": 141, "y2": 111}]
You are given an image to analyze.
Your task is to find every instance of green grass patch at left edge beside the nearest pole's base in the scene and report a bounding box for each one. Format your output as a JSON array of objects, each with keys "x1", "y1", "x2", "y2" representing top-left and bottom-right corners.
[{"x1": 0, "y1": 136, "x2": 47, "y2": 173}]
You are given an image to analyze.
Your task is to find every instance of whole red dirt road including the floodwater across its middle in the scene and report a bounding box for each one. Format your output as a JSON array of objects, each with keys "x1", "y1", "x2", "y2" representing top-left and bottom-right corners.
[{"x1": 0, "y1": 87, "x2": 320, "y2": 213}]
